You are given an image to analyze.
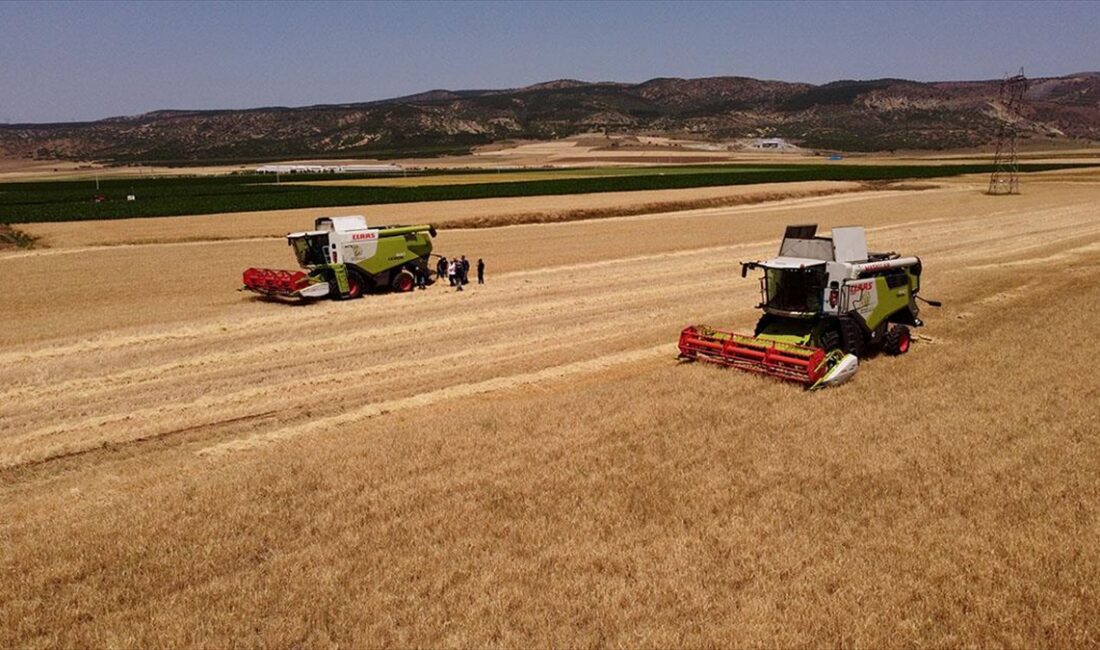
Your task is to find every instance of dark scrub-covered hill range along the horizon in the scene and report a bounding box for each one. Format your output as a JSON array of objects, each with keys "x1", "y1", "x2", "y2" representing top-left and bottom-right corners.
[{"x1": 0, "y1": 73, "x2": 1100, "y2": 163}]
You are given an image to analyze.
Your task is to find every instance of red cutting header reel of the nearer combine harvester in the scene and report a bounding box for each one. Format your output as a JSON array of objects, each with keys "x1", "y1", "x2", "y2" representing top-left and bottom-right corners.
[{"x1": 680, "y1": 326, "x2": 828, "y2": 386}]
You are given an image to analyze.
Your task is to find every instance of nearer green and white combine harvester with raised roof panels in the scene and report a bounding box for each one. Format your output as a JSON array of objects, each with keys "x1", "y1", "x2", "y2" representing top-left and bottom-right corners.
[{"x1": 679, "y1": 225, "x2": 937, "y2": 388}]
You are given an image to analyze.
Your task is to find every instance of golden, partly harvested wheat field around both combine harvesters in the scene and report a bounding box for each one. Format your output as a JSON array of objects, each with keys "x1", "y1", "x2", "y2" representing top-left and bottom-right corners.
[{"x1": 0, "y1": 174, "x2": 1100, "y2": 648}]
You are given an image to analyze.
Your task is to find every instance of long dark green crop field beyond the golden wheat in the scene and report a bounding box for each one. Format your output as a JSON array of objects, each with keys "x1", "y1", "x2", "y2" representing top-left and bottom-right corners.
[{"x1": 0, "y1": 163, "x2": 1097, "y2": 223}]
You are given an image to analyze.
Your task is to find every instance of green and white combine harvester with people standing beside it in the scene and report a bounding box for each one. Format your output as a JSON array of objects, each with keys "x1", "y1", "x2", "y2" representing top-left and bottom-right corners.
[{"x1": 243, "y1": 216, "x2": 436, "y2": 299}]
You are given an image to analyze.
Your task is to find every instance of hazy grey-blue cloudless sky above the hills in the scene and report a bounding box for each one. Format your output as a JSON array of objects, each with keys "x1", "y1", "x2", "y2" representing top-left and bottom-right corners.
[{"x1": 0, "y1": 1, "x2": 1100, "y2": 123}]
